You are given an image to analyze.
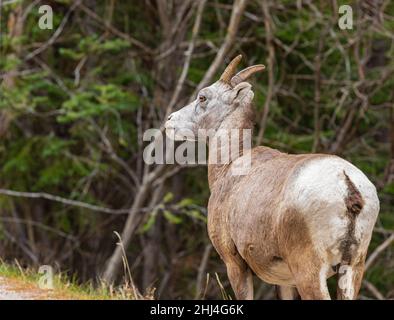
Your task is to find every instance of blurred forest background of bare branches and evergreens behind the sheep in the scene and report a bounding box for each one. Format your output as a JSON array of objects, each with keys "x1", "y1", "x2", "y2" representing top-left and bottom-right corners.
[{"x1": 0, "y1": 0, "x2": 394, "y2": 299}]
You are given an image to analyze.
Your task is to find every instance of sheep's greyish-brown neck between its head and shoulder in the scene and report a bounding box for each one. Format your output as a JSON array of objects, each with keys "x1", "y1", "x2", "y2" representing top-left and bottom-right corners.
[{"x1": 208, "y1": 108, "x2": 253, "y2": 190}]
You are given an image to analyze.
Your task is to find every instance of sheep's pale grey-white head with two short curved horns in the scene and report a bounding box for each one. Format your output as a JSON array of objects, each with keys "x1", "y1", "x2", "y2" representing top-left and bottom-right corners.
[{"x1": 165, "y1": 55, "x2": 265, "y2": 140}]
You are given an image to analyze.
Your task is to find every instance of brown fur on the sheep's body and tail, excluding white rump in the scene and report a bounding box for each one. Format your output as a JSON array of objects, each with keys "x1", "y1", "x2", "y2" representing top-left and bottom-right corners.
[{"x1": 208, "y1": 105, "x2": 362, "y2": 299}]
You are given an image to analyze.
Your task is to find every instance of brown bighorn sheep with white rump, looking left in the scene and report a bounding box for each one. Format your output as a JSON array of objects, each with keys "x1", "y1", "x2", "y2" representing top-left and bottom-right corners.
[{"x1": 165, "y1": 56, "x2": 379, "y2": 299}]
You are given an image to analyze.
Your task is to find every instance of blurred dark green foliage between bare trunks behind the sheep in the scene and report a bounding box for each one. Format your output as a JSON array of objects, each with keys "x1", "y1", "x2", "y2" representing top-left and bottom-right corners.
[{"x1": 0, "y1": 0, "x2": 394, "y2": 298}]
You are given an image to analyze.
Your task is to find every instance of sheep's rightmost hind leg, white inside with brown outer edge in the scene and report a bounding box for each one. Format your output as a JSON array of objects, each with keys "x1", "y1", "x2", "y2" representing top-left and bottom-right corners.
[{"x1": 337, "y1": 258, "x2": 365, "y2": 300}]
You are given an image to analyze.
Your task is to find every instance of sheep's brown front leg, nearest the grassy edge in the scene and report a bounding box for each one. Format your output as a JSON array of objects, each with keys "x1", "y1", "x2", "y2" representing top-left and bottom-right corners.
[{"x1": 226, "y1": 257, "x2": 253, "y2": 300}]
